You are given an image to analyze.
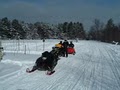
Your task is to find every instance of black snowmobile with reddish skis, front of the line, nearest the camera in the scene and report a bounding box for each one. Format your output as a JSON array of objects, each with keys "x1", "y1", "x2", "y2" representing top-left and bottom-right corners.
[{"x1": 27, "y1": 51, "x2": 57, "y2": 73}]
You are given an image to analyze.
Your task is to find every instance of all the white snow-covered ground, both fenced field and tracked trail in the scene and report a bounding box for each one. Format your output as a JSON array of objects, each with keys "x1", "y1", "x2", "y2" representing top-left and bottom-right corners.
[{"x1": 0, "y1": 40, "x2": 120, "y2": 90}]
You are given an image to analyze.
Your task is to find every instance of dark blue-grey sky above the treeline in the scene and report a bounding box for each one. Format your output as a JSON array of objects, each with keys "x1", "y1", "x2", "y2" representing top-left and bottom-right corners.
[{"x1": 0, "y1": 0, "x2": 120, "y2": 29}]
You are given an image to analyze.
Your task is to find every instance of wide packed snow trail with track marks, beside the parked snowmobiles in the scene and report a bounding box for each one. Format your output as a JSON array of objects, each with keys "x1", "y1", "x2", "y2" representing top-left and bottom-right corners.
[{"x1": 0, "y1": 41, "x2": 120, "y2": 90}]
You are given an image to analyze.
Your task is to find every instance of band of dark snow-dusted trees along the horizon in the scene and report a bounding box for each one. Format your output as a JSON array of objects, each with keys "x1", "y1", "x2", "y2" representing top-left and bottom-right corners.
[{"x1": 0, "y1": 17, "x2": 120, "y2": 42}]
